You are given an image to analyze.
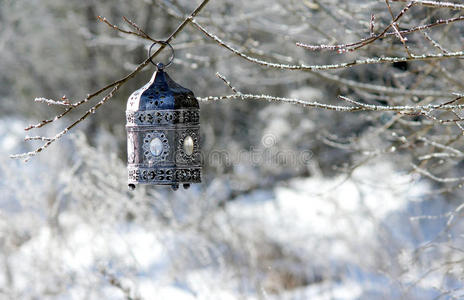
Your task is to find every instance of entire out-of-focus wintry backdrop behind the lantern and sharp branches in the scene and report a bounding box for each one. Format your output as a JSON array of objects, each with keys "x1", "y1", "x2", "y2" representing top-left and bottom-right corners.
[{"x1": 0, "y1": 0, "x2": 464, "y2": 300}]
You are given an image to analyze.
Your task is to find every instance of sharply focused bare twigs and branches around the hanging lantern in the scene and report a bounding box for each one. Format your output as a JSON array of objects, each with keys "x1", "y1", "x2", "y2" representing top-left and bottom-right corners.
[{"x1": 11, "y1": 0, "x2": 464, "y2": 164}]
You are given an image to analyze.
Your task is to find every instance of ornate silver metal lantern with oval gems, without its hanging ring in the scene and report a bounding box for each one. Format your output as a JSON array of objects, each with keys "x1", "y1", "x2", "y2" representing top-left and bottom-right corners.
[{"x1": 126, "y1": 67, "x2": 201, "y2": 189}]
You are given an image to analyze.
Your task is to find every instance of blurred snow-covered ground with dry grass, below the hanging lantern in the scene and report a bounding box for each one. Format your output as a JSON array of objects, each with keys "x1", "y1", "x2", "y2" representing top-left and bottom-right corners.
[{"x1": 0, "y1": 121, "x2": 464, "y2": 300}]
